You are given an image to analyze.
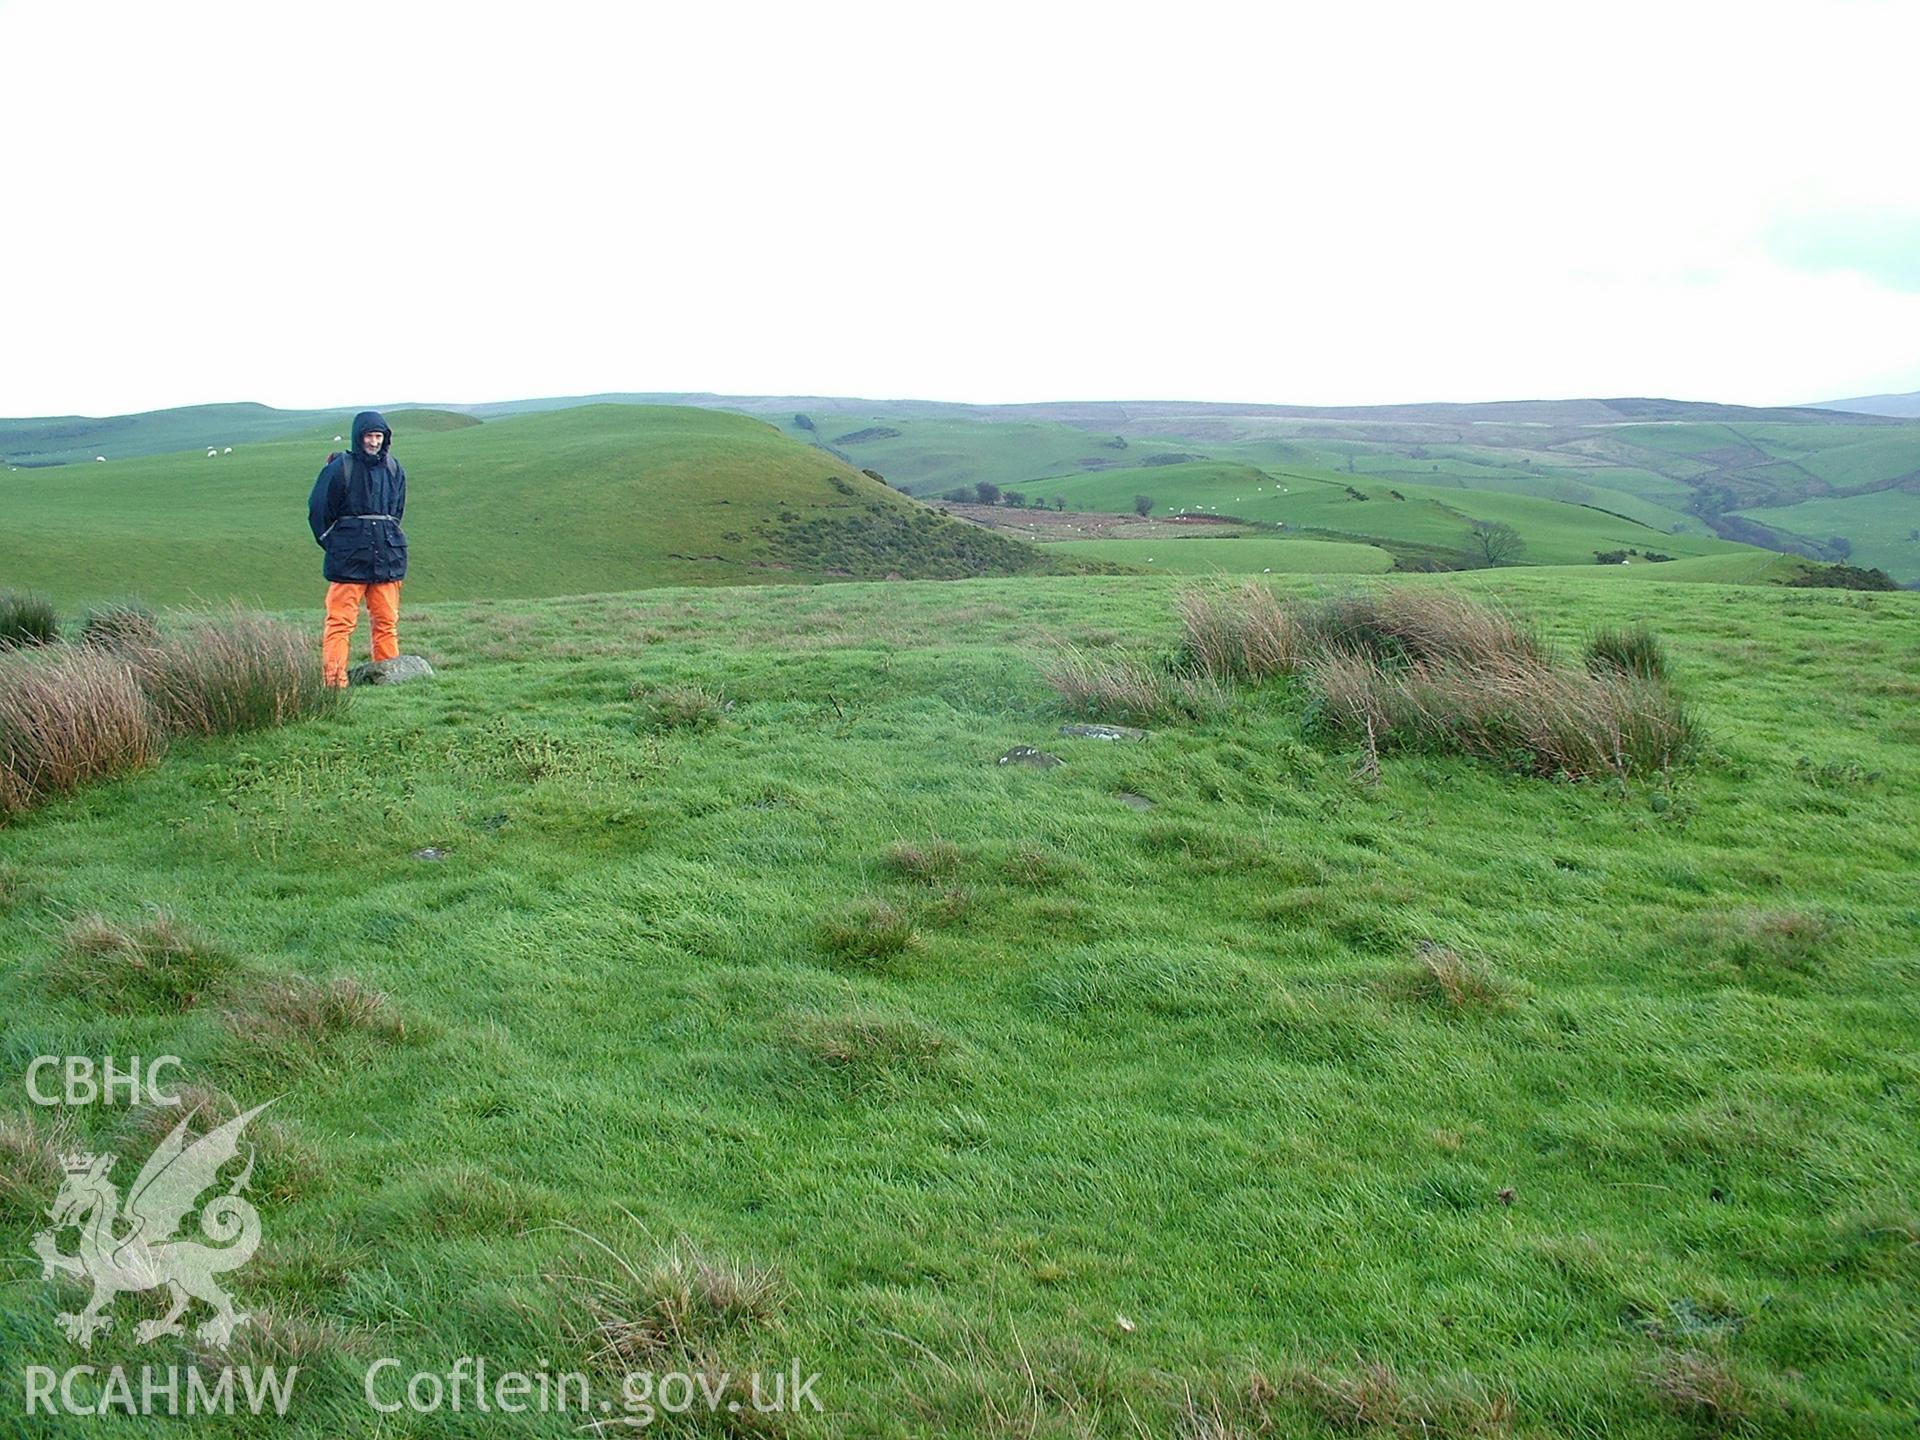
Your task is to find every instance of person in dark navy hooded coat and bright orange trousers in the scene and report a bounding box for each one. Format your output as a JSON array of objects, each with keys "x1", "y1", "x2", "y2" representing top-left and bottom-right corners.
[{"x1": 307, "y1": 411, "x2": 407, "y2": 689}]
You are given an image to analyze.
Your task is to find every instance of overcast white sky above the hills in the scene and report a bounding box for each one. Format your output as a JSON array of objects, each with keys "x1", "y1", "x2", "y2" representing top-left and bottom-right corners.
[{"x1": 0, "y1": 0, "x2": 1920, "y2": 415}]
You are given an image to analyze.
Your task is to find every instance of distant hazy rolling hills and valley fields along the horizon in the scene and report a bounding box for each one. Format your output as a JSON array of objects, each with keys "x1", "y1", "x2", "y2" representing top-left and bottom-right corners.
[{"x1": 0, "y1": 394, "x2": 1920, "y2": 584}]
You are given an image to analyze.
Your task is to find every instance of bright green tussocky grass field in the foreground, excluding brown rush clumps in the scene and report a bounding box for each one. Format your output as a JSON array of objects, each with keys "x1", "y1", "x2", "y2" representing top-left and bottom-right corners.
[{"x1": 0, "y1": 568, "x2": 1920, "y2": 1440}]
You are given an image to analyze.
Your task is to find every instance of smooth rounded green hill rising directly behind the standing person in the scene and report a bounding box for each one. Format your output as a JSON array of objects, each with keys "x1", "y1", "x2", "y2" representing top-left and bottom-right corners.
[{"x1": 0, "y1": 405, "x2": 1071, "y2": 607}]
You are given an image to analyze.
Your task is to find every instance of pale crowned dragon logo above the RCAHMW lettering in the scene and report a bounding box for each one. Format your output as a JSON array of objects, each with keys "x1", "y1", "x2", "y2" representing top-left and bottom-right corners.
[{"x1": 33, "y1": 1100, "x2": 273, "y2": 1350}]
